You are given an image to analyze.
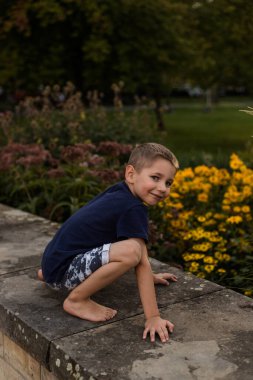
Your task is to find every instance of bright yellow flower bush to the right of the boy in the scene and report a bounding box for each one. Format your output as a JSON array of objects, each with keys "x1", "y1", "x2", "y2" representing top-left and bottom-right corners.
[{"x1": 151, "y1": 154, "x2": 253, "y2": 296}]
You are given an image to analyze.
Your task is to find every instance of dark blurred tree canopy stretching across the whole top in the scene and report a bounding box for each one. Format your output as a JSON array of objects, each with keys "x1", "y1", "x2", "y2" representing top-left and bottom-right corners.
[{"x1": 0, "y1": 0, "x2": 253, "y2": 95}]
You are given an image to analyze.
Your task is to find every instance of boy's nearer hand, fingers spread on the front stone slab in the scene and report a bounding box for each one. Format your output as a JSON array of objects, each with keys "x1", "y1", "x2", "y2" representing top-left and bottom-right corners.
[{"x1": 143, "y1": 316, "x2": 174, "y2": 343}]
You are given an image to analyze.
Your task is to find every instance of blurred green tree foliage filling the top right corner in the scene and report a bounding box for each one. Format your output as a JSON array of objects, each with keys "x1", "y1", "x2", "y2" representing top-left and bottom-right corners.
[{"x1": 188, "y1": 0, "x2": 253, "y2": 105}]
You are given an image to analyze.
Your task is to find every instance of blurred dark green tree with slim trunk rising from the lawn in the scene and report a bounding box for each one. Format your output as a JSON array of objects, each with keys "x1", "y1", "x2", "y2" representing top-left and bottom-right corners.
[{"x1": 101, "y1": 0, "x2": 190, "y2": 129}]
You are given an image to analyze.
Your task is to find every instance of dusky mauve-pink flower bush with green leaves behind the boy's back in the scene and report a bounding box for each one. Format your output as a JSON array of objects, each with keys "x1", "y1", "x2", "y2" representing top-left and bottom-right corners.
[{"x1": 0, "y1": 141, "x2": 132, "y2": 222}]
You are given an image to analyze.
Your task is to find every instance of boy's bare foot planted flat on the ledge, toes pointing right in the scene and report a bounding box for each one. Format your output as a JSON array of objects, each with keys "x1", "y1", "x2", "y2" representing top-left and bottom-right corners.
[{"x1": 63, "y1": 298, "x2": 117, "y2": 322}]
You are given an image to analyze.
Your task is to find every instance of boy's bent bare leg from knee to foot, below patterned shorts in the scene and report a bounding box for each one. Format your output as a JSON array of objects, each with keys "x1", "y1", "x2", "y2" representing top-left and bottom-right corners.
[{"x1": 63, "y1": 239, "x2": 144, "y2": 322}]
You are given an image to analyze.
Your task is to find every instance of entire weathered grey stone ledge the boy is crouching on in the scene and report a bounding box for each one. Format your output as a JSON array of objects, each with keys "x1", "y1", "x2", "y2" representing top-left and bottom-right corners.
[{"x1": 0, "y1": 205, "x2": 253, "y2": 380}]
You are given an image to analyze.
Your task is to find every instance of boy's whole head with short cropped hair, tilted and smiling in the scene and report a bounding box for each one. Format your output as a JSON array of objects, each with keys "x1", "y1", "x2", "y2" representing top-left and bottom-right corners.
[{"x1": 125, "y1": 143, "x2": 179, "y2": 206}]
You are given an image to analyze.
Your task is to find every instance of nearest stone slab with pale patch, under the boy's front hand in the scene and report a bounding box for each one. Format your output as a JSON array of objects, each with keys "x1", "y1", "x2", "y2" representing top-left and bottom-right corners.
[{"x1": 50, "y1": 290, "x2": 253, "y2": 380}]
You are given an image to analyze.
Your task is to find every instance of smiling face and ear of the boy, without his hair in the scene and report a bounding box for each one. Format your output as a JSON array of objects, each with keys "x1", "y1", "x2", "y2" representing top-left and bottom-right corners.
[{"x1": 126, "y1": 158, "x2": 176, "y2": 206}]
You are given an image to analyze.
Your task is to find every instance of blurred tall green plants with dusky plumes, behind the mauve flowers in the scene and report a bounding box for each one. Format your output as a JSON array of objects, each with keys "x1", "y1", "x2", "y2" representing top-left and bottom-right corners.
[{"x1": 0, "y1": 82, "x2": 155, "y2": 148}]
